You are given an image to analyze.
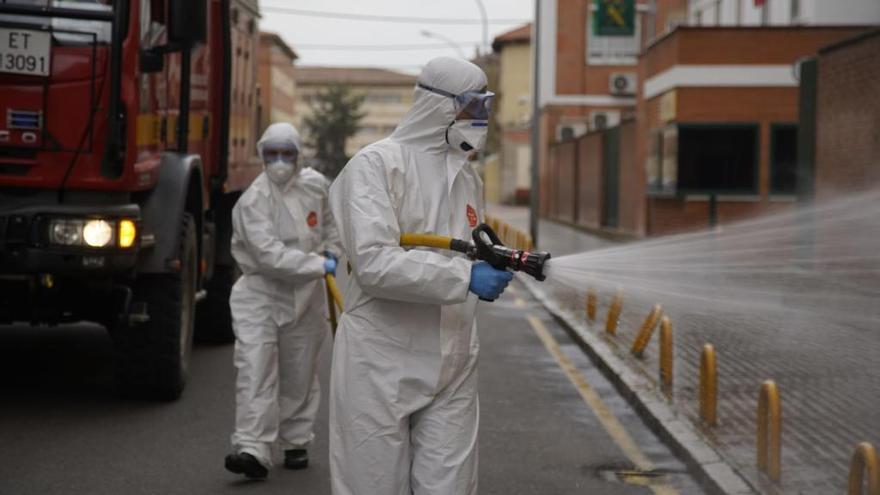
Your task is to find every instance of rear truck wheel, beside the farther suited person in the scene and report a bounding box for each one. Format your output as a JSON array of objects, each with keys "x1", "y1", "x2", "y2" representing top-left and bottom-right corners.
[{"x1": 196, "y1": 265, "x2": 239, "y2": 344}]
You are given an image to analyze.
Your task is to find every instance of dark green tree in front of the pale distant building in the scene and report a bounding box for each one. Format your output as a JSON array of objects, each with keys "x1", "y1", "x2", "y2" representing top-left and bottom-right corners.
[{"x1": 303, "y1": 84, "x2": 365, "y2": 177}]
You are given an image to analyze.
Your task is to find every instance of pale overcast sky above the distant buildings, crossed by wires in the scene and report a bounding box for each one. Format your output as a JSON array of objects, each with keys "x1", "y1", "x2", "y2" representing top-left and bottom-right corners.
[{"x1": 254, "y1": 0, "x2": 535, "y2": 72}]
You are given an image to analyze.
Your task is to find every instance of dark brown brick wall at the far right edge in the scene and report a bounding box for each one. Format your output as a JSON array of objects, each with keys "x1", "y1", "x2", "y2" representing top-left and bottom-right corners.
[{"x1": 816, "y1": 32, "x2": 880, "y2": 198}]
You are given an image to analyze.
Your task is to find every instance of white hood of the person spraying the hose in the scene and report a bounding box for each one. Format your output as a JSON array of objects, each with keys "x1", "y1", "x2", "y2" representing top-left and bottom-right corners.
[{"x1": 391, "y1": 57, "x2": 488, "y2": 153}]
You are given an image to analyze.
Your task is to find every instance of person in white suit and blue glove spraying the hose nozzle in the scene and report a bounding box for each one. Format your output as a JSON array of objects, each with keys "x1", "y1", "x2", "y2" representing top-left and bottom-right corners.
[{"x1": 330, "y1": 57, "x2": 512, "y2": 495}]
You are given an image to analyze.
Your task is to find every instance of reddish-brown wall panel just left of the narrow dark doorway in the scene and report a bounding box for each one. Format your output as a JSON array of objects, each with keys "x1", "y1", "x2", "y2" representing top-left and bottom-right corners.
[{"x1": 577, "y1": 133, "x2": 602, "y2": 229}]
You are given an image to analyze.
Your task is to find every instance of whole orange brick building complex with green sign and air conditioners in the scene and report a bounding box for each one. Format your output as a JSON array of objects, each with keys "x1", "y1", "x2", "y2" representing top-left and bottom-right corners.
[{"x1": 538, "y1": 0, "x2": 880, "y2": 237}]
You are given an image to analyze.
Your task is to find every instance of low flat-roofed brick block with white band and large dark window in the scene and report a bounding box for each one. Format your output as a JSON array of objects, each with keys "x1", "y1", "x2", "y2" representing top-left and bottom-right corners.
[{"x1": 640, "y1": 27, "x2": 863, "y2": 235}]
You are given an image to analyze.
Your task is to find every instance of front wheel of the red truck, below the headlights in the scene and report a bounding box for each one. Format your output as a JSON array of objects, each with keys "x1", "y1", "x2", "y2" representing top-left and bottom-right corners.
[{"x1": 114, "y1": 213, "x2": 198, "y2": 400}]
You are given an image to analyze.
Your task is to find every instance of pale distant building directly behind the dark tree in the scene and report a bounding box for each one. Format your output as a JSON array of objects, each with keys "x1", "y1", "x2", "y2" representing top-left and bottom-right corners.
[{"x1": 293, "y1": 67, "x2": 416, "y2": 156}]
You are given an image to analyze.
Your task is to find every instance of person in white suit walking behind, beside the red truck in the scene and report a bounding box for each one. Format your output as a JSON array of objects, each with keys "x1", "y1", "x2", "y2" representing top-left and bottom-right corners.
[{"x1": 226, "y1": 123, "x2": 340, "y2": 479}]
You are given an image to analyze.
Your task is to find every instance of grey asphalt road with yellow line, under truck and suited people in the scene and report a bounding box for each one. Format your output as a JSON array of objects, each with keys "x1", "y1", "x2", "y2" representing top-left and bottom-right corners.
[{"x1": 0, "y1": 280, "x2": 701, "y2": 495}]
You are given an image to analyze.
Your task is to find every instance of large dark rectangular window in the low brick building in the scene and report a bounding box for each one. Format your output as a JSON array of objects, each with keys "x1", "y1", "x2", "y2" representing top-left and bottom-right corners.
[{"x1": 676, "y1": 124, "x2": 758, "y2": 194}]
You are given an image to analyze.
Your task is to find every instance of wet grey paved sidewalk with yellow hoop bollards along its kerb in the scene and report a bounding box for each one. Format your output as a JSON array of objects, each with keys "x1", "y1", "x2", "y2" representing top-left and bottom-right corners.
[{"x1": 488, "y1": 205, "x2": 880, "y2": 494}]
